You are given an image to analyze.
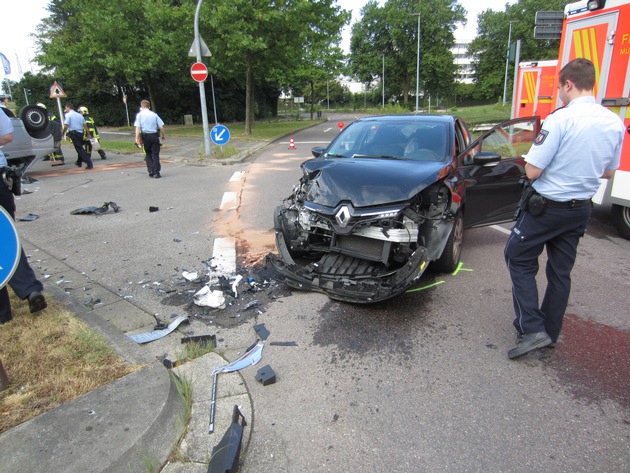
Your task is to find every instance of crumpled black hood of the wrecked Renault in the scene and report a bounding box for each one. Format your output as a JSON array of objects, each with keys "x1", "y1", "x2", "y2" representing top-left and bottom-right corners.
[{"x1": 302, "y1": 158, "x2": 448, "y2": 207}]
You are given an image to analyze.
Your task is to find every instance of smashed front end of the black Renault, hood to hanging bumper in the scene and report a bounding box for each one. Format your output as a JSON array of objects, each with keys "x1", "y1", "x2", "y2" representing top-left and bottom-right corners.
[{"x1": 267, "y1": 158, "x2": 455, "y2": 303}]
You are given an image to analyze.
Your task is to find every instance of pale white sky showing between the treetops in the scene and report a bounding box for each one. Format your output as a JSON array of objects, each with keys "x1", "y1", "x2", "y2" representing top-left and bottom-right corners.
[{"x1": 0, "y1": 0, "x2": 513, "y2": 81}]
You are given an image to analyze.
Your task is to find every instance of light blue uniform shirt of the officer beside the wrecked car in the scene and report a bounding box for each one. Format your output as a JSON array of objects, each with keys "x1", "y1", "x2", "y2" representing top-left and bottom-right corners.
[{"x1": 525, "y1": 96, "x2": 625, "y2": 202}]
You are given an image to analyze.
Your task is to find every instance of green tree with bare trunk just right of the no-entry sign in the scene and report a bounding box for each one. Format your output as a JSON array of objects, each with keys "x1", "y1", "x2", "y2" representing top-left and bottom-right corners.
[{"x1": 206, "y1": 0, "x2": 349, "y2": 134}]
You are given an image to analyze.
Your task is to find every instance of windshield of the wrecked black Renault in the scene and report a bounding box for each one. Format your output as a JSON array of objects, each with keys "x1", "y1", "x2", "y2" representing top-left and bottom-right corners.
[{"x1": 325, "y1": 120, "x2": 451, "y2": 162}]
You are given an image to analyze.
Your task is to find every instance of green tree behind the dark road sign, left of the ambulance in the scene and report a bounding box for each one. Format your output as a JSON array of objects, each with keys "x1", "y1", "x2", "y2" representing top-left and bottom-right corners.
[{"x1": 468, "y1": 0, "x2": 568, "y2": 99}]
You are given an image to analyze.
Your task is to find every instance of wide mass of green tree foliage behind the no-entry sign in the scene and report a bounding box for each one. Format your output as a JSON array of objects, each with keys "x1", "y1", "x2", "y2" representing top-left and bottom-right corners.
[{"x1": 29, "y1": 0, "x2": 349, "y2": 129}]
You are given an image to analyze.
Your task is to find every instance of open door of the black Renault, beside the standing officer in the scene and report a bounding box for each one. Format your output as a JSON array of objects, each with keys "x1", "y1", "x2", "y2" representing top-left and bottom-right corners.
[{"x1": 457, "y1": 117, "x2": 540, "y2": 227}]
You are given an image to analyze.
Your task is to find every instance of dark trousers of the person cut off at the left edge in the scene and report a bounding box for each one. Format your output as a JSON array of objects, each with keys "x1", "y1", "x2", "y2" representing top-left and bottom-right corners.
[{"x1": 0, "y1": 181, "x2": 44, "y2": 323}]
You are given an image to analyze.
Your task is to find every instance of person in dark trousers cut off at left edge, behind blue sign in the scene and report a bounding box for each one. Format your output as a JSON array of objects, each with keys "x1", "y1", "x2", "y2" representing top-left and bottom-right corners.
[{"x1": 0, "y1": 106, "x2": 47, "y2": 324}]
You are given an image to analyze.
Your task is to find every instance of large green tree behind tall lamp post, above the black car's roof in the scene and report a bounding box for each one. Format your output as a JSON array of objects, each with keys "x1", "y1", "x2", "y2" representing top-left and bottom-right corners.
[{"x1": 349, "y1": 0, "x2": 466, "y2": 103}]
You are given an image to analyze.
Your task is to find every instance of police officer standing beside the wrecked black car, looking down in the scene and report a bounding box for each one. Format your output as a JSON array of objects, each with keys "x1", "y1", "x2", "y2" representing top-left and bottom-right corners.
[{"x1": 505, "y1": 58, "x2": 625, "y2": 359}]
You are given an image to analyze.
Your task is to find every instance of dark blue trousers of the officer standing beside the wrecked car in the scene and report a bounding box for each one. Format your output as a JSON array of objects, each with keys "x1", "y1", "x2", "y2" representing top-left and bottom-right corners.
[{"x1": 505, "y1": 203, "x2": 591, "y2": 341}]
